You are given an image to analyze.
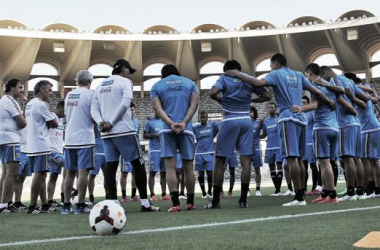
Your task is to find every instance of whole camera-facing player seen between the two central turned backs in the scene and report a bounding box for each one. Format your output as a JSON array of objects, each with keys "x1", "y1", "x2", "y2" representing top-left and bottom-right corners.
[{"x1": 193, "y1": 110, "x2": 218, "y2": 198}]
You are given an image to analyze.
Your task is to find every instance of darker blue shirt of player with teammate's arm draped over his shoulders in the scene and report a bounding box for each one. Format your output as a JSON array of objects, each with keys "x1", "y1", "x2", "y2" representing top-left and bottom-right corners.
[{"x1": 213, "y1": 75, "x2": 265, "y2": 116}]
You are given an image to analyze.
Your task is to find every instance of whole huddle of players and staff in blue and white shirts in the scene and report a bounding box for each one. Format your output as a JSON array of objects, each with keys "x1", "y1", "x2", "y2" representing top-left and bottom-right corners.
[{"x1": 0, "y1": 54, "x2": 380, "y2": 214}]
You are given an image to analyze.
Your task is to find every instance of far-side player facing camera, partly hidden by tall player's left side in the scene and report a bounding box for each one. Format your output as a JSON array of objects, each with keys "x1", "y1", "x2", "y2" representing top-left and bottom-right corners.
[{"x1": 260, "y1": 102, "x2": 284, "y2": 196}]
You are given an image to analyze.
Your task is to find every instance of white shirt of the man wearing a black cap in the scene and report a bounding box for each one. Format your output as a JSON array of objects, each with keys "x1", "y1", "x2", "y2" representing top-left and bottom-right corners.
[{"x1": 92, "y1": 75, "x2": 136, "y2": 139}]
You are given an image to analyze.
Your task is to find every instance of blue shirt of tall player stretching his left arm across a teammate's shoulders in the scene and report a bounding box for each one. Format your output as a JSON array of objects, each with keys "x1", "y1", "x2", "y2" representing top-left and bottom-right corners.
[{"x1": 264, "y1": 67, "x2": 311, "y2": 125}]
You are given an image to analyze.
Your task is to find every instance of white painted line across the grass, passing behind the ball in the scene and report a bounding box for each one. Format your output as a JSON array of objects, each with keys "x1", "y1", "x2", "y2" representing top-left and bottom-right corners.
[{"x1": 0, "y1": 206, "x2": 380, "y2": 248}]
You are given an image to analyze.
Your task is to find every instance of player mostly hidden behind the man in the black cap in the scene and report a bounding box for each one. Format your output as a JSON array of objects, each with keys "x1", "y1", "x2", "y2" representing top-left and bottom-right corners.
[{"x1": 119, "y1": 102, "x2": 140, "y2": 202}]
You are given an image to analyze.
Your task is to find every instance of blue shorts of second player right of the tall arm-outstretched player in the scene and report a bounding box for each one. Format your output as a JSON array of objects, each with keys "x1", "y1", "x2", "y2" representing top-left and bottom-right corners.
[{"x1": 339, "y1": 126, "x2": 362, "y2": 157}]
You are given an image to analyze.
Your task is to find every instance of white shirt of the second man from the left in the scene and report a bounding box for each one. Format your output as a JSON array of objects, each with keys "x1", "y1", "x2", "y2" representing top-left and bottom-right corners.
[{"x1": 25, "y1": 98, "x2": 55, "y2": 156}]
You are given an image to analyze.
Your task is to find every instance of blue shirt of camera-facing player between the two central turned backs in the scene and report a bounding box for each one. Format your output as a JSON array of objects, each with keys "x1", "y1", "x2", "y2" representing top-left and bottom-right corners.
[{"x1": 193, "y1": 122, "x2": 218, "y2": 154}]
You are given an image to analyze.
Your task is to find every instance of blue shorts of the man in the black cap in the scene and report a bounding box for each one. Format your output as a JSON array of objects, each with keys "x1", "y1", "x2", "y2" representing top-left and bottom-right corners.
[{"x1": 103, "y1": 134, "x2": 144, "y2": 162}]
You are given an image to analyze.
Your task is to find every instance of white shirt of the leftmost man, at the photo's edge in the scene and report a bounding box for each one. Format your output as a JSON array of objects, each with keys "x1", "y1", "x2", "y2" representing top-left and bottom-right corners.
[{"x1": 0, "y1": 95, "x2": 22, "y2": 145}]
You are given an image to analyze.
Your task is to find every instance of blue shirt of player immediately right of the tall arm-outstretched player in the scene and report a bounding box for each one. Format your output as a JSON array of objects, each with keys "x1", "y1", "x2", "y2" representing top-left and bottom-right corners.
[{"x1": 313, "y1": 84, "x2": 339, "y2": 132}]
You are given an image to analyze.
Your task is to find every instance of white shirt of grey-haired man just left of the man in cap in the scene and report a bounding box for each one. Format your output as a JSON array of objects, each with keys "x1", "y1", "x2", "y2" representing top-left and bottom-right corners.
[{"x1": 65, "y1": 87, "x2": 95, "y2": 148}]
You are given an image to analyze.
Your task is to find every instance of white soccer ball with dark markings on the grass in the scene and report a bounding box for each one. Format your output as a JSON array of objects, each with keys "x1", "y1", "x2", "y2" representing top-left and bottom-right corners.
[{"x1": 89, "y1": 200, "x2": 127, "y2": 235}]
